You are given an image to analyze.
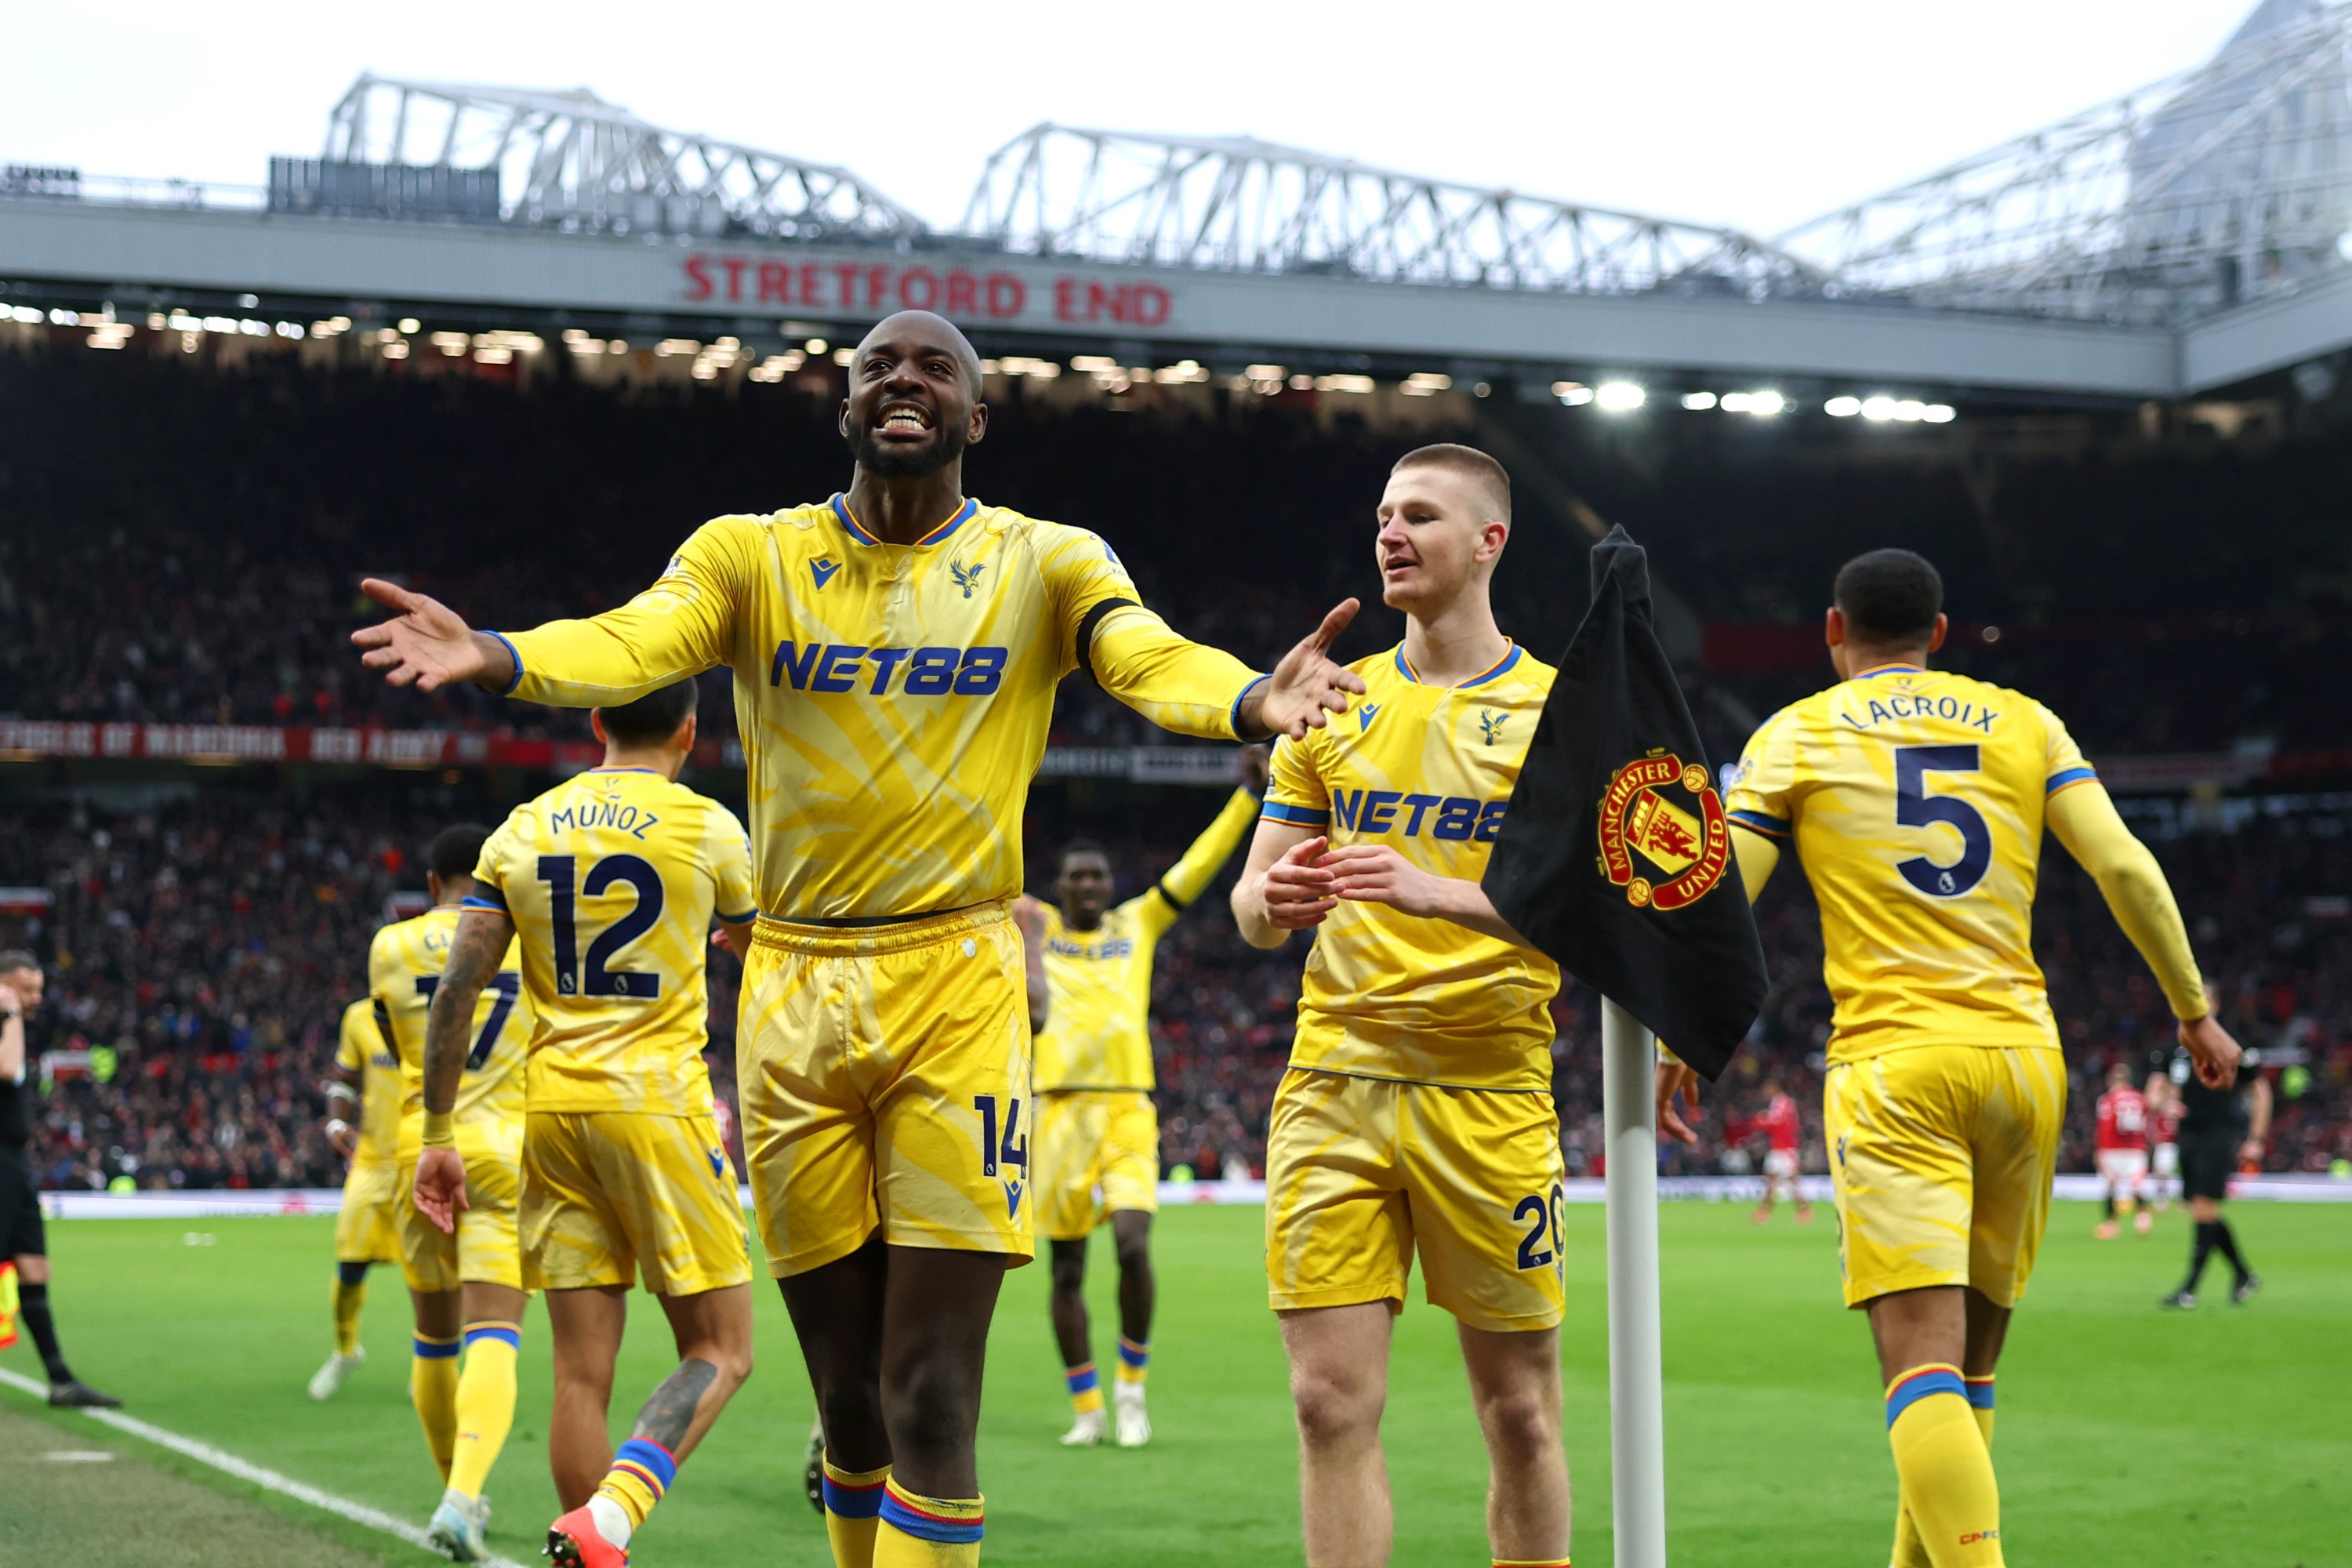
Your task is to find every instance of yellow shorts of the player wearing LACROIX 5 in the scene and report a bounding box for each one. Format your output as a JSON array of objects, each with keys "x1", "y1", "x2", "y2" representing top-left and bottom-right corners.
[{"x1": 1823, "y1": 1046, "x2": 2065, "y2": 1307}]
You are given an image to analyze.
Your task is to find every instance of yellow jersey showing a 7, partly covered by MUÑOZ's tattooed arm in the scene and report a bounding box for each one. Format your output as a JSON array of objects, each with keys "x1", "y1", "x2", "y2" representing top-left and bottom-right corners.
[{"x1": 367, "y1": 905, "x2": 532, "y2": 1161}]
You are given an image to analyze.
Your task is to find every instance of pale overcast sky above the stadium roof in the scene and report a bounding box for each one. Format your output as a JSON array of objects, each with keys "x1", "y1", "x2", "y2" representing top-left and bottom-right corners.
[{"x1": 0, "y1": 0, "x2": 2253, "y2": 235}]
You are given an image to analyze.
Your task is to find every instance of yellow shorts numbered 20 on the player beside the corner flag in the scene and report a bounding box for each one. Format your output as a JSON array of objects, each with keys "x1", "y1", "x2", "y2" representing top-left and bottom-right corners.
[{"x1": 1265, "y1": 1067, "x2": 1566, "y2": 1333}]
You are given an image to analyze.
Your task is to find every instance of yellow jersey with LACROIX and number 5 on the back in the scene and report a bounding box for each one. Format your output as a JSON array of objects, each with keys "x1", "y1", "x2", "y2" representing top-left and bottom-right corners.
[{"x1": 1724, "y1": 666, "x2": 2096, "y2": 1062}]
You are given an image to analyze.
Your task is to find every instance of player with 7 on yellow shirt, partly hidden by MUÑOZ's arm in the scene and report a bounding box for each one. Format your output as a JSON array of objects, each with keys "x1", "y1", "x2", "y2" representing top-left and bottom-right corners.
[{"x1": 367, "y1": 822, "x2": 532, "y2": 1563}]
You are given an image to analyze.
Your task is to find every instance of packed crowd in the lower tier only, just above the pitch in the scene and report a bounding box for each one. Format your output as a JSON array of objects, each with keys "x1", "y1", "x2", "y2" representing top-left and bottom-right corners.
[{"x1": 0, "y1": 789, "x2": 2352, "y2": 1187}]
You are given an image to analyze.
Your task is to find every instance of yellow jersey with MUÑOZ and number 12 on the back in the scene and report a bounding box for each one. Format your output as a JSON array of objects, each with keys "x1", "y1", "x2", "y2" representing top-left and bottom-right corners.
[{"x1": 482, "y1": 769, "x2": 755, "y2": 1116}]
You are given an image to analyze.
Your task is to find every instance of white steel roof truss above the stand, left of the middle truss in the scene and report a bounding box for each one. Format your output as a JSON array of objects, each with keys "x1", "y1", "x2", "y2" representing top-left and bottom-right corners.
[{"x1": 322, "y1": 73, "x2": 927, "y2": 242}]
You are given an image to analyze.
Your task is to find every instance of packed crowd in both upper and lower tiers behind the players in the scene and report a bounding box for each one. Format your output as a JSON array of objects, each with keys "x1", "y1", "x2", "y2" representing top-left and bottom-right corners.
[{"x1": 0, "y1": 355, "x2": 2352, "y2": 1187}]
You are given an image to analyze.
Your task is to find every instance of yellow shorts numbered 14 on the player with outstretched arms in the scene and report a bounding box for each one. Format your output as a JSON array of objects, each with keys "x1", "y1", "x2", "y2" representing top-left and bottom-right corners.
[{"x1": 736, "y1": 902, "x2": 1035, "y2": 1279}]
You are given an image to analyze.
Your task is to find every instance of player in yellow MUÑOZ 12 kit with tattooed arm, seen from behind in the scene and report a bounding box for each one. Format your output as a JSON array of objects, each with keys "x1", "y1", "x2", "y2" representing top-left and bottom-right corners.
[{"x1": 419, "y1": 680, "x2": 755, "y2": 1568}]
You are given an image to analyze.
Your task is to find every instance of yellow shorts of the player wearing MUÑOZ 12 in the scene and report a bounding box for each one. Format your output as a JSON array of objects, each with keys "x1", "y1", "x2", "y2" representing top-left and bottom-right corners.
[{"x1": 522, "y1": 1109, "x2": 750, "y2": 1295}]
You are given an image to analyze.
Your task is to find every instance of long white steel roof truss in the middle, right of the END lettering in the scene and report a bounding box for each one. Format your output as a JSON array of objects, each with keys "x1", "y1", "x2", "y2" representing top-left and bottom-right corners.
[{"x1": 962, "y1": 122, "x2": 1823, "y2": 299}]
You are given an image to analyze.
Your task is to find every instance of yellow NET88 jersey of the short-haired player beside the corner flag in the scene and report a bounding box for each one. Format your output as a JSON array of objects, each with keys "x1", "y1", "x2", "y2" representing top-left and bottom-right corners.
[{"x1": 1265, "y1": 644, "x2": 1559, "y2": 1088}]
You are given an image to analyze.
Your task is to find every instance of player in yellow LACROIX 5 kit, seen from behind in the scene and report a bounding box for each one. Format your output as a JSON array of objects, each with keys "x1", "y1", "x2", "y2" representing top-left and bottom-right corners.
[{"x1": 1658, "y1": 550, "x2": 2237, "y2": 1568}]
